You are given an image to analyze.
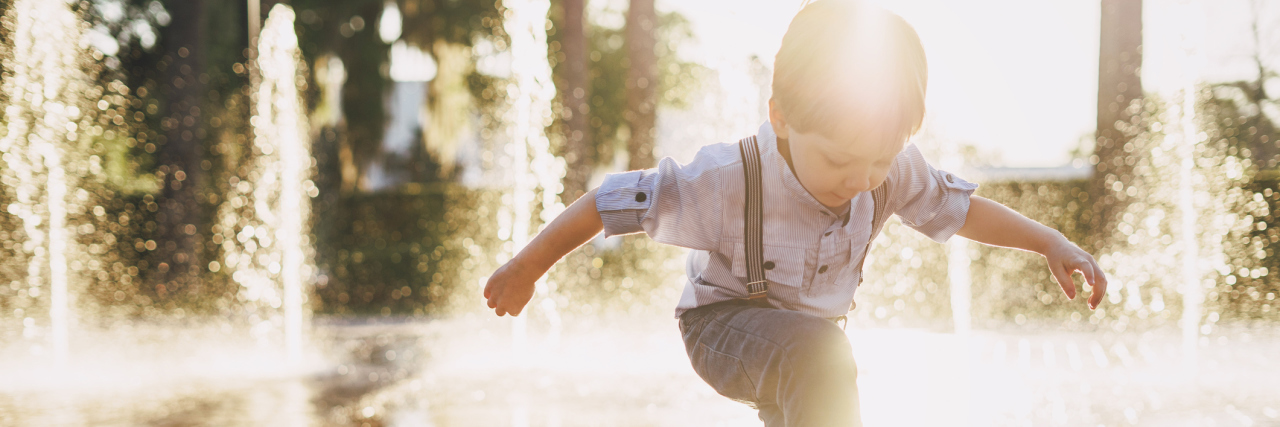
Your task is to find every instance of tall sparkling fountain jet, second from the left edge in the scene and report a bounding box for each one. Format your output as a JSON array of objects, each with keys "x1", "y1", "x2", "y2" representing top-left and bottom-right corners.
[{"x1": 218, "y1": 5, "x2": 316, "y2": 362}]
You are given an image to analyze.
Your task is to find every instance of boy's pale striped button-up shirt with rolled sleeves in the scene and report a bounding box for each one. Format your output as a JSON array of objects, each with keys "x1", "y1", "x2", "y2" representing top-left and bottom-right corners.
[{"x1": 595, "y1": 123, "x2": 978, "y2": 317}]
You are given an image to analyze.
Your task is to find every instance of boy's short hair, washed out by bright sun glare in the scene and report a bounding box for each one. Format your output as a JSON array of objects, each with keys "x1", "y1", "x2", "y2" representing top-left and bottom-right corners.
[{"x1": 773, "y1": 0, "x2": 929, "y2": 139}]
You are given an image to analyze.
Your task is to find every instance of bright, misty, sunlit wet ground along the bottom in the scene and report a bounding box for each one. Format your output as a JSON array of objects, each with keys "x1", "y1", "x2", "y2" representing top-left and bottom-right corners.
[{"x1": 0, "y1": 313, "x2": 1280, "y2": 427}]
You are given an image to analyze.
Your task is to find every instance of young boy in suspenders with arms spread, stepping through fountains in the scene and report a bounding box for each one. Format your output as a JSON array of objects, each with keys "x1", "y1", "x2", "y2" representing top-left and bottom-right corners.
[{"x1": 484, "y1": 0, "x2": 1106, "y2": 427}]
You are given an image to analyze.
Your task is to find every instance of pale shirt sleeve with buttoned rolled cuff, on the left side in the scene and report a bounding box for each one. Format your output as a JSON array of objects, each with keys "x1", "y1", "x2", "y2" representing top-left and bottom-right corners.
[{"x1": 595, "y1": 147, "x2": 736, "y2": 251}]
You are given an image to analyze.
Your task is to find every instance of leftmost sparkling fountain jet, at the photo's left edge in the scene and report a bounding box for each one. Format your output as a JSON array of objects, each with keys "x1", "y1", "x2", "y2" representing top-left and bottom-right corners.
[{"x1": 0, "y1": 0, "x2": 88, "y2": 364}]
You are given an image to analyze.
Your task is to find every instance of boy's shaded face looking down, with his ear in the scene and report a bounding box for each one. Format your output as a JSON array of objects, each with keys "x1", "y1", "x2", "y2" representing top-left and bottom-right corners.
[{"x1": 769, "y1": 101, "x2": 906, "y2": 207}]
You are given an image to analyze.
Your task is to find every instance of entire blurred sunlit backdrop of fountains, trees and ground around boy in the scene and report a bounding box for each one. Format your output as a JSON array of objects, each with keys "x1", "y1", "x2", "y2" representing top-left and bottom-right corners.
[{"x1": 0, "y1": 0, "x2": 1280, "y2": 426}]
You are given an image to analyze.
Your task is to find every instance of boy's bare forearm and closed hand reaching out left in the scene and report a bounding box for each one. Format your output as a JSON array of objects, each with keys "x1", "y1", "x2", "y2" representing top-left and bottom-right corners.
[{"x1": 484, "y1": 189, "x2": 604, "y2": 316}]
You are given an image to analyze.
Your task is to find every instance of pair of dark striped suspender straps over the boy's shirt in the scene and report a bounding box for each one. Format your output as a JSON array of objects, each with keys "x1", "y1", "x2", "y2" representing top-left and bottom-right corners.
[{"x1": 737, "y1": 137, "x2": 888, "y2": 304}]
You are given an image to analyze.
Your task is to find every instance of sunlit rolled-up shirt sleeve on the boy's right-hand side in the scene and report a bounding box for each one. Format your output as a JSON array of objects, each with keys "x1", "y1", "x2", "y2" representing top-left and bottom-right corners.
[{"x1": 888, "y1": 144, "x2": 978, "y2": 242}]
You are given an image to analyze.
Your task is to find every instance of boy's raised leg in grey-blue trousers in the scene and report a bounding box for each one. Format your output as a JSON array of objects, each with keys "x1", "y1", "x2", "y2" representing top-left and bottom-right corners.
[{"x1": 680, "y1": 304, "x2": 861, "y2": 427}]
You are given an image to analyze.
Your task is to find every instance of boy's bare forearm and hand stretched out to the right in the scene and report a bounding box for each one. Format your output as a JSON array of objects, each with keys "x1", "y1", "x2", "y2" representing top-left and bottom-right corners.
[{"x1": 956, "y1": 196, "x2": 1107, "y2": 309}]
